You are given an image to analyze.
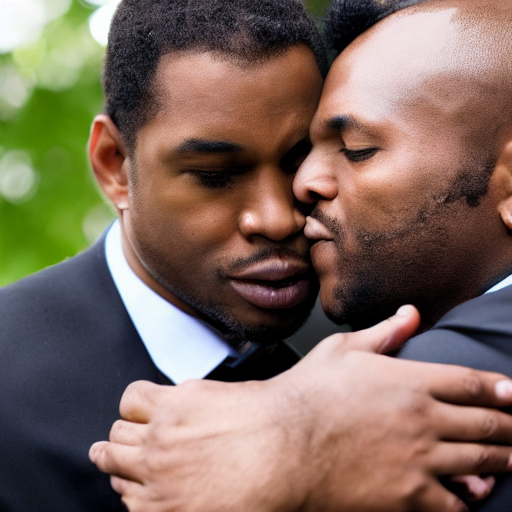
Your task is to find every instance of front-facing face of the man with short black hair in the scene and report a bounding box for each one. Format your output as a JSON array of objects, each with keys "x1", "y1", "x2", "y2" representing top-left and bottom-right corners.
[{"x1": 122, "y1": 46, "x2": 322, "y2": 340}]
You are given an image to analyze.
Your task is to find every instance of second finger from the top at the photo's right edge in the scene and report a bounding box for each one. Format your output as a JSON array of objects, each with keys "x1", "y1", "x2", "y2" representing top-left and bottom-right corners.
[{"x1": 432, "y1": 402, "x2": 512, "y2": 445}]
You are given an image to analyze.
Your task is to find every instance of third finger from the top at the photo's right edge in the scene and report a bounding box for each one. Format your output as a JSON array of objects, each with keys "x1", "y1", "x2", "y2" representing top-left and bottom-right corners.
[{"x1": 429, "y1": 442, "x2": 512, "y2": 476}]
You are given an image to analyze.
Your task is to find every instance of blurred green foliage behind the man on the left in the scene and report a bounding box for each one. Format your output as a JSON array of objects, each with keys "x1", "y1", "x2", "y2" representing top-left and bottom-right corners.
[{"x1": 0, "y1": 0, "x2": 328, "y2": 286}]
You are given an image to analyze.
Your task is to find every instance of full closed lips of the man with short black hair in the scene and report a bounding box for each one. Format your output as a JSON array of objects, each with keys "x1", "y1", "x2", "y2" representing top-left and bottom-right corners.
[{"x1": 231, "y1": 260, "x2": 311, "y2": 309}]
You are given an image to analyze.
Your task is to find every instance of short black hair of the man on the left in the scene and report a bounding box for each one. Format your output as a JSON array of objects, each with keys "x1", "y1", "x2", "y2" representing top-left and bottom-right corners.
[{"x1": 102, "y1": 0, "x2": 328, "y2": 149}]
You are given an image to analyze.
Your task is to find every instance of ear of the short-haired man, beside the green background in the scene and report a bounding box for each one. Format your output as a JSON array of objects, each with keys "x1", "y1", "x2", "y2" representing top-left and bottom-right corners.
[{"x1": 89, "y1": 114, "x2": 130, "y2": 211}]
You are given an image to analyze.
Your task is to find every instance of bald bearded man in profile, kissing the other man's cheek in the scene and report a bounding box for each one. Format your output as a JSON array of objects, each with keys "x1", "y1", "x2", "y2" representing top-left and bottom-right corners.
[{"x1": 294, "y1": 0, "x2": 512, "y2": 512}]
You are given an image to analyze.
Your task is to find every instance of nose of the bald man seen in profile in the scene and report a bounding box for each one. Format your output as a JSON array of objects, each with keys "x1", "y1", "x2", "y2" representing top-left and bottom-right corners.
[{"x1": 293, "y1": 150, "x2": 338, "y2": 204}]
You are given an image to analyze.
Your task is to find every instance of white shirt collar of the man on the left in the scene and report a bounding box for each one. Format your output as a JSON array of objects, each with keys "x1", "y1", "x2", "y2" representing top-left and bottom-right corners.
[{"x1": 105, "y1": 221, "x2": 238, "y2": 384}]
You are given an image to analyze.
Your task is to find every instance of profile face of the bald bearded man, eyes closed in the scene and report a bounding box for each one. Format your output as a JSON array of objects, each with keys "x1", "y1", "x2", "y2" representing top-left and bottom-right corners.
[{"x1": 294, "y1": 12, "x2": 502, "y2": 328}]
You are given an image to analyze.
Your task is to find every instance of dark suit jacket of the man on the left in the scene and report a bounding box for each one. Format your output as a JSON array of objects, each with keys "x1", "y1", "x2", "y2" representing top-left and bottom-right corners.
[{"x1": 0, "y1": 239, "x2": 298, "y2": 512}]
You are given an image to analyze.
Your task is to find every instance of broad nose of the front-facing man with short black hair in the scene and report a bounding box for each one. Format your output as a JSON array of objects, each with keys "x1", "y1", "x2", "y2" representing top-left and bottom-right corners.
[{"x1": 239, "y1": 170, "x2": 306, "y2": 242}]
